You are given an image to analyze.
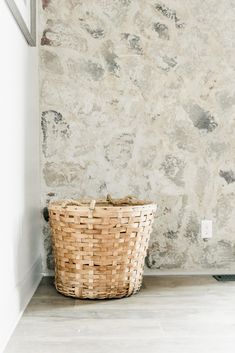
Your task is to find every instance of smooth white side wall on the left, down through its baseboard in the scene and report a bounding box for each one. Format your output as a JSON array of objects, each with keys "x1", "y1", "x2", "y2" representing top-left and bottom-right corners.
[{"x1": 0, "y1": 0, "x2": 41, "y2": 352}]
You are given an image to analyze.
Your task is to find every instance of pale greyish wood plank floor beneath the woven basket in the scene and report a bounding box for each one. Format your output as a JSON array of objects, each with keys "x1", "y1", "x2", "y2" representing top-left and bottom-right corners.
[{"x1": 5, "y1": 276, "x2": 235, "y2": 353}]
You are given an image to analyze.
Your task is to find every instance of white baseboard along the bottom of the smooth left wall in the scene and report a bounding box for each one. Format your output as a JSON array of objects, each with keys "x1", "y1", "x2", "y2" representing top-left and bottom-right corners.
[{"x1": 0, "y1": 257, "x2": 42, "y2": 353}]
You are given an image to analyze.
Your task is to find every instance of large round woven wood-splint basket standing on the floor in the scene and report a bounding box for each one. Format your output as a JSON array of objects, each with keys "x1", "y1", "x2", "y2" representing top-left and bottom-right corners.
[{"x1": 49, "y1": 197, "x2": 156, "y2": 299}]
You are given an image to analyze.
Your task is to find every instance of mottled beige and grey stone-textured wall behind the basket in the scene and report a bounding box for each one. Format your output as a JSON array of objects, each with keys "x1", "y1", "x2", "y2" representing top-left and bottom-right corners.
[{"x1": 39, "y1": 0, "x2": 235, "y2": 271}]
